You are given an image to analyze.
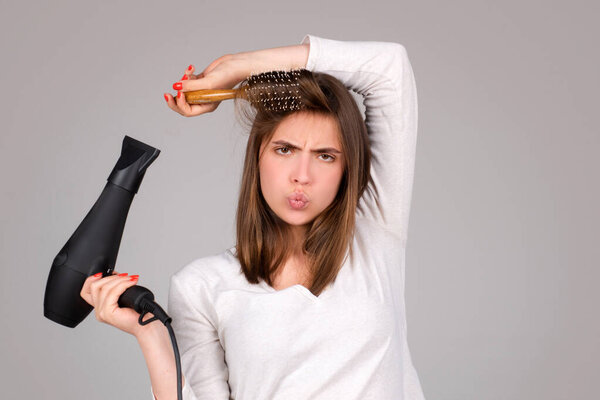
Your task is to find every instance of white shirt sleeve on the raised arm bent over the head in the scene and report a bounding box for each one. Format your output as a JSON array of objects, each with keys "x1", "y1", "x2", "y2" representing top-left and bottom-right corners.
[{"x1": 302, "y1": 35, "x2": 418, "y2": 246}]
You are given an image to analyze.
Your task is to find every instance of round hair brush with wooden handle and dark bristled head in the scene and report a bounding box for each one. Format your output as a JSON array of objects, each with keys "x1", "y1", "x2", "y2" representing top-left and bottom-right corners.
[{"x1": 184, "y1": 69, "x2": 308, "y2": 111}]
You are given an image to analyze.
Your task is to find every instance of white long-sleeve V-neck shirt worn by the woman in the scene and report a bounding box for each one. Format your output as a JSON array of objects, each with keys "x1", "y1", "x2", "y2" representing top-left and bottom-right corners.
[{"x1": 152, "y1": 35, "x2": 424, "y2": 400}]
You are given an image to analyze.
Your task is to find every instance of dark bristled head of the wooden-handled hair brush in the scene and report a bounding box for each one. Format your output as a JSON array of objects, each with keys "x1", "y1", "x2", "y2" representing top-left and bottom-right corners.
[{"x1": 242, "y1": 69, "x2": 308, "y2": 112}]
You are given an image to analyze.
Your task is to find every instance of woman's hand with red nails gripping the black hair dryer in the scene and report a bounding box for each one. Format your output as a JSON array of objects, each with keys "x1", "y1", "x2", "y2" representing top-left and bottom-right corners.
[{"x1": 80, "y1": 271, "x2": 141, "y2": 336}]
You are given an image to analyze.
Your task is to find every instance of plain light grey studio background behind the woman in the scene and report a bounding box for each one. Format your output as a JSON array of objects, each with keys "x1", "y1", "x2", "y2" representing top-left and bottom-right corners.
[{"x1": 0, "y1": 0, "x2": 600, "y2": 400}]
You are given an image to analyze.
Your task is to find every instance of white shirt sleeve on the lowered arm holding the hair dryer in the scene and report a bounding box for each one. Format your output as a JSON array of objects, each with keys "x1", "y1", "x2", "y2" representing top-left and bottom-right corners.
[{"x1": 152, "y1": 274, "x2": 230, "y2": 400}]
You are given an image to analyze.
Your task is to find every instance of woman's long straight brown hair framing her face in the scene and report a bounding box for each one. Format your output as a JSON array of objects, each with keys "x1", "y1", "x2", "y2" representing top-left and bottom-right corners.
[{"x1": 235, "y1": 70, "x2": 371, "y2": 296}]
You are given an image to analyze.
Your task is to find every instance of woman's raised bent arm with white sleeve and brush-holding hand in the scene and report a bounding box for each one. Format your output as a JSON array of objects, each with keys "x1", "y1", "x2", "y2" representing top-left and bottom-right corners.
[{"x1": 165, "y1": 35, "x2": 418, "y2": 246}]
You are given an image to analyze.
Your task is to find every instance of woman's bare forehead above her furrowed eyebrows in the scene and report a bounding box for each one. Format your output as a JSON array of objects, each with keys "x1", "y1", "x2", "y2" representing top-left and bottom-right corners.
[{"x1": 271, "y1": 112, "x2": 340, "y2": 148}]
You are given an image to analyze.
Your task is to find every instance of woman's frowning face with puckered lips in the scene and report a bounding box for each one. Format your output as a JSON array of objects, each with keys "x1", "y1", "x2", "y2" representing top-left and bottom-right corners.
[{"x1": 258, "y1": 111, "x2": 344, "y2": 226}]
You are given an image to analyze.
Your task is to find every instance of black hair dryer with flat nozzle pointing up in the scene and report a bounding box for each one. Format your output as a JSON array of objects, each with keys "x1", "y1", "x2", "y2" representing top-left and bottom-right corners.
[{"x1": 44, "y1": 136, "x2": 160, "y2": 328}]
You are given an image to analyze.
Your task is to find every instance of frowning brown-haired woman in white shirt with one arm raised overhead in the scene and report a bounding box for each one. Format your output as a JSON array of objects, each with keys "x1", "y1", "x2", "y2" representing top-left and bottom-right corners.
[{"x1": 82, "y1": 35, "x2": 423, "y2": 400}]
